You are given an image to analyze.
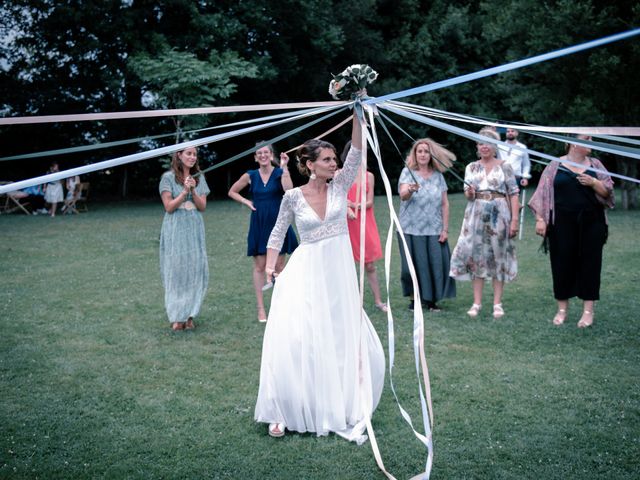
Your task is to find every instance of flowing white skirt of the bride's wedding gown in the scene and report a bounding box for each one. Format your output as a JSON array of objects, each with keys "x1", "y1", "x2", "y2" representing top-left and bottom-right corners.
[{"x1": 255, "y1": 235, "x2": 385, "y2": 444}]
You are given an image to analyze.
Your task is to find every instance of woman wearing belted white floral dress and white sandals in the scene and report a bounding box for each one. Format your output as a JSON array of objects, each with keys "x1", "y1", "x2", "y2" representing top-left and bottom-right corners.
[{"x1": 450, "y1": 129, "x2": 519, "y2": 319}]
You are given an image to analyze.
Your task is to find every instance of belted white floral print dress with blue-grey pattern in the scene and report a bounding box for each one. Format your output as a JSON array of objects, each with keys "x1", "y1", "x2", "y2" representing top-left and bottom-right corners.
[{"x1": 449, "y1": 162, "x2": 519, "y2": 282}]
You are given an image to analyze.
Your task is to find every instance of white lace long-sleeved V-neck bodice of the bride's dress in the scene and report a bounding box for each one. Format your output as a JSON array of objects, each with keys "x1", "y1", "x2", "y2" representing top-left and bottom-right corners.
[{"x1": 267, "y1": 147, "x2": 362, "y2": 251}]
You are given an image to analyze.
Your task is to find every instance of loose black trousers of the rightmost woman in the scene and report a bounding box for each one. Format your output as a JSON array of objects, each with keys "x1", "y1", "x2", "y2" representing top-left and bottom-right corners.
[{"x1": 548, "y1": 209, "x2": 607, "y2": 300}]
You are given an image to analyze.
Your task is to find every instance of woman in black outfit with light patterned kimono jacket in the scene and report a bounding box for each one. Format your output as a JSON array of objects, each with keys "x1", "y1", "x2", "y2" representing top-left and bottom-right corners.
[{"x1": 529, "y1": 135, "x2": 614, "y2": 328}]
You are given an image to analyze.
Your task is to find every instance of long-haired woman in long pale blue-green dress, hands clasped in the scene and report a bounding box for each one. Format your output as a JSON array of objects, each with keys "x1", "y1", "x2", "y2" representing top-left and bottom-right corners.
[{"x1": 159, "y1": 147, "x2": 209, "y2": 330}]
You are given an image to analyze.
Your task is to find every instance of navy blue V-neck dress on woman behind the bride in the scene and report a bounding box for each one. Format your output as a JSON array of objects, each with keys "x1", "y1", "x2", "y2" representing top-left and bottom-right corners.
[{"x1": 247, "y1": 168, "x2": 298, "y2": 257}]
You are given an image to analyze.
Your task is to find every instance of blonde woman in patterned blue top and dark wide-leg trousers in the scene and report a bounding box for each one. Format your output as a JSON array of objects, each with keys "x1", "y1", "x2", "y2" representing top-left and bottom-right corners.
[{"x1": 398, "y1": 138, "x2": 456, "y2": 312}]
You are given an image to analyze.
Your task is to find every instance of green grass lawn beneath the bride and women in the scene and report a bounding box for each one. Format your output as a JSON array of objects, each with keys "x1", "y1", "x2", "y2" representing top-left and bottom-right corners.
[{"x1": 0, "y1": 195, "x2": 640, "y2": 480}]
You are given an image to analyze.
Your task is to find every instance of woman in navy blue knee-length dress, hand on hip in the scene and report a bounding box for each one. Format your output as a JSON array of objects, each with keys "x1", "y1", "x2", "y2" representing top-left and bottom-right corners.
[{"x1": 229, "y1": 145, "x2": 298, "y2": 322}]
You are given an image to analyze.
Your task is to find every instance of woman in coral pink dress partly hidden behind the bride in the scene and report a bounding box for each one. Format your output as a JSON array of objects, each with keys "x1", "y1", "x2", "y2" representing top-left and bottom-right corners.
[{"x1": 342, "y1": 142, "x2": 387, "y2": 312}]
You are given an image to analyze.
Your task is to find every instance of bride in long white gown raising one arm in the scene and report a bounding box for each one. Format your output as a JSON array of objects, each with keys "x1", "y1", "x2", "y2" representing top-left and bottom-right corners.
[{"x1": 255, "y1": 114, "x2": 385, "y2": 444}]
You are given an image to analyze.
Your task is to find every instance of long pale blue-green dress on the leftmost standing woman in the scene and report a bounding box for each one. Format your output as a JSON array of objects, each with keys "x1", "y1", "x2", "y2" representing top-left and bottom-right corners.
[{"x1": 160, "y1": 171, "x2": 209, "y2": 323}]
